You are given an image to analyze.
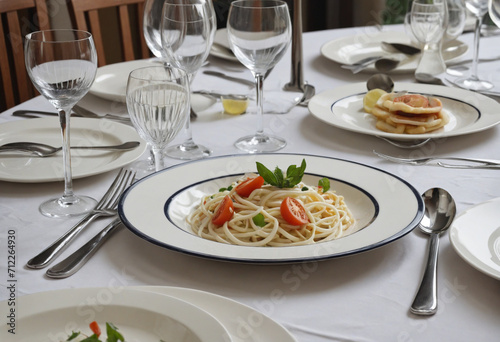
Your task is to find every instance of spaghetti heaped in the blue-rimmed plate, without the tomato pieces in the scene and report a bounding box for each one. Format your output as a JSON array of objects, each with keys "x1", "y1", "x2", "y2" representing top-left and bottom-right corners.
[{"x1": 187, "y1": 176, "x2": 355, "y2": 247}]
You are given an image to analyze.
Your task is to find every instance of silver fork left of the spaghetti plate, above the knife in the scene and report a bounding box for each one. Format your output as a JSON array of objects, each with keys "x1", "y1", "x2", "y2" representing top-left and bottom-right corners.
[{"x1": 26, "y1": 169, "x2": 135, "y2": 269}]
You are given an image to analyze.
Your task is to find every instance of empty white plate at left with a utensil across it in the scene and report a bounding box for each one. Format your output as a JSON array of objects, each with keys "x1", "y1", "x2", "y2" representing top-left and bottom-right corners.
[{"x1": 0, "y1": 118, "x2": 146, "y2": 183}]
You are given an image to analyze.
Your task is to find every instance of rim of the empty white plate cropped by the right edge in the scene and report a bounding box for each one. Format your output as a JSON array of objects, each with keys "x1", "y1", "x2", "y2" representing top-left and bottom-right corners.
[{"x1": 448, "y1": 197, "x2": 500, "y2": 280}]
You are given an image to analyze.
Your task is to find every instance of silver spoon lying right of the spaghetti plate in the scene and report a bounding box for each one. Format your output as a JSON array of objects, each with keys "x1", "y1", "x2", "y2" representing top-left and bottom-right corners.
[{"x1": 410, "y1": 188, "x2": 457, "y2": 315}]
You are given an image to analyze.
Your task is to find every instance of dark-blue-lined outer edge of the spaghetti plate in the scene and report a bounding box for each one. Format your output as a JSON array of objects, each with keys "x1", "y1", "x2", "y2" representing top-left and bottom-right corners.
[{"x1": 118, "y1": 153, "x2": 424, "y2": 264}]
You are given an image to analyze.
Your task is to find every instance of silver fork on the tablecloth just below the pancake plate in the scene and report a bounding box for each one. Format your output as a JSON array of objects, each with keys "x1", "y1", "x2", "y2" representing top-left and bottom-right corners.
[{"x1": 373, "y1": 150, "x2": 500, "y2": 169}]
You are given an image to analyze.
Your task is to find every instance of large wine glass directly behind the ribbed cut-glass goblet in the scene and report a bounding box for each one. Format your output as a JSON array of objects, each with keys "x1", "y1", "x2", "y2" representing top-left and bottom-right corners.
[{"x1": 161, "y1": 0, "x2": 216, "y2": 159}]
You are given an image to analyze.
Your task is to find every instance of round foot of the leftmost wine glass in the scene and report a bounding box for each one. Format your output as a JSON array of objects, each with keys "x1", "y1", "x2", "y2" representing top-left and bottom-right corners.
[{"x1": 39, "y1": 196, "x2": 97, "y2": 217}]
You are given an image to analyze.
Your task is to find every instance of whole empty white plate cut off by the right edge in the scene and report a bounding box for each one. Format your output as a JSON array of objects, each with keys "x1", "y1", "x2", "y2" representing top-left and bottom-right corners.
[{"x1": 450, "y1": 198, "x2": 500, "y2": 280}]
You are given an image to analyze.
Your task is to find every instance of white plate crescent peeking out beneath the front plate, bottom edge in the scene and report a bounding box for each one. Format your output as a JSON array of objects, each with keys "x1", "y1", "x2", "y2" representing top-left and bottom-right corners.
[{"x1": 139, "y1": 286, "x2": 297, "y2": 342}]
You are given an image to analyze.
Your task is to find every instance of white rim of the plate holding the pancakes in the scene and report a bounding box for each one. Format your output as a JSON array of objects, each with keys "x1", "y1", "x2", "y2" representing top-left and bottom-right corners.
[{"x1": 308, "y1": 82, "x2": 500, "y2": 140}]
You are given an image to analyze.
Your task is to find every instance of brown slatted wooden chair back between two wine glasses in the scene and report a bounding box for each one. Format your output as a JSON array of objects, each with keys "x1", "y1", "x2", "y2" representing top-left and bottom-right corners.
[{"x1": 71, "y1": 0, "x2": 150, "y2": 66}]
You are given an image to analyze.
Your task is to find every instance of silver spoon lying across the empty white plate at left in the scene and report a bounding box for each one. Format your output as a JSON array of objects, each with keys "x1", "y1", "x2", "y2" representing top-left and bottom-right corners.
[{"x1": 0, "y1": 141, "x2": 140, "y2": 157}]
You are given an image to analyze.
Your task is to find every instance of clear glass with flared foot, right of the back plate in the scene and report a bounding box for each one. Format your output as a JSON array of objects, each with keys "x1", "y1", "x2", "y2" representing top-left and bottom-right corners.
[{"x1": 410, "y1": 0, "x2": 448, "y2": 75}]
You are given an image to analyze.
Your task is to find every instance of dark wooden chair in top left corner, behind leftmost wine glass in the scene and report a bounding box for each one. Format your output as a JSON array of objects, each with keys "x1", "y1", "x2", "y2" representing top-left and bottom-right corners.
[{"x1": 0, "y1": 0, "x2": 50, "y2": 111}]
